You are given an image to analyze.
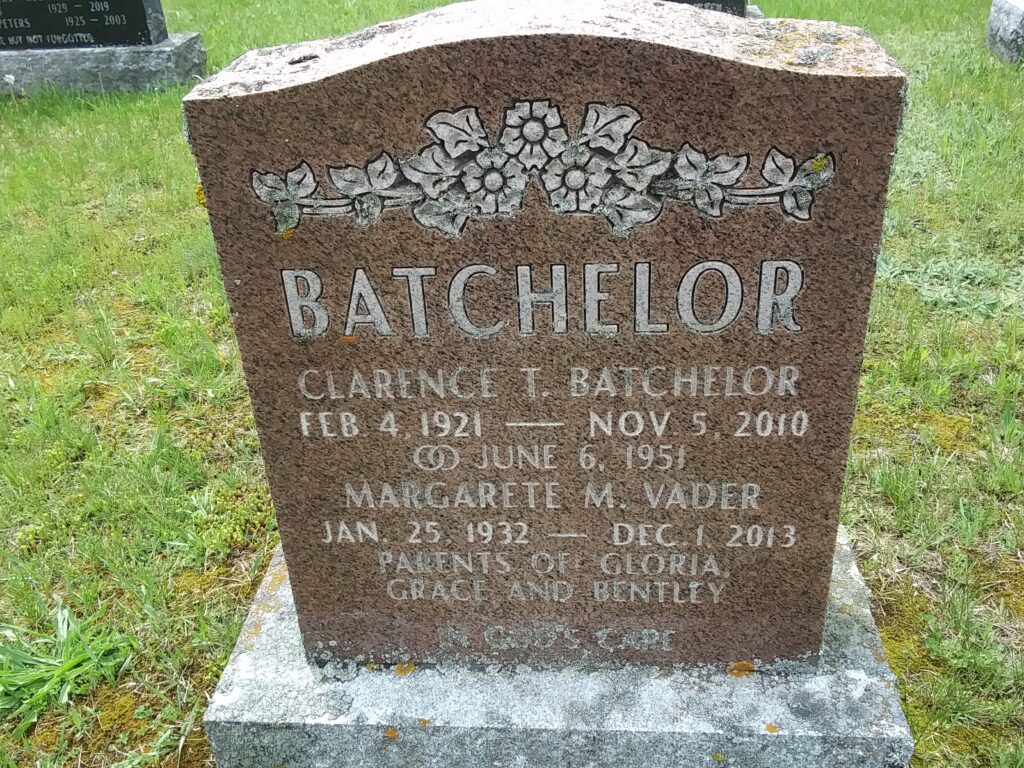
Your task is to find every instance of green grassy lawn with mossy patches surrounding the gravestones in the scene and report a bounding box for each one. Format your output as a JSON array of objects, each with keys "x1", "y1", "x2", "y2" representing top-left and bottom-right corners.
[{"x1": 0, "y1": 0, "x2": 1024, "y2": 768}]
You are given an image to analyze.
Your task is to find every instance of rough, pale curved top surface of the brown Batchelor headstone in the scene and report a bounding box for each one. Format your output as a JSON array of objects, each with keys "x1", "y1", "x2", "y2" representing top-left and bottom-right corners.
[{"x1": 186, "y1": 0, "x2": 903, "y2": 99}]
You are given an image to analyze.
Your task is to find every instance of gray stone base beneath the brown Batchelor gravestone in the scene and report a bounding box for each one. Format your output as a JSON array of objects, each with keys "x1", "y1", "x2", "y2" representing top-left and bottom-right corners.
[{"x1": 206, "y1": 543, "x2": 913, "y2": 768}]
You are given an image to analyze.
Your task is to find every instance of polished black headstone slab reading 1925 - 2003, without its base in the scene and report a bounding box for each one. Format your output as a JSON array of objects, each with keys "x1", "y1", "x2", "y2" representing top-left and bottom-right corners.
[{"x1": 0, "y1": 0, "x2": 167, "y2": 49}]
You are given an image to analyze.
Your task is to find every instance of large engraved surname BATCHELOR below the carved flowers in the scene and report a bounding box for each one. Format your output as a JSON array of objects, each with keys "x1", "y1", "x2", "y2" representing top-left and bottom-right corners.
[{"x1": 281, "y1": 259, "x2": 804, "y2": 339}]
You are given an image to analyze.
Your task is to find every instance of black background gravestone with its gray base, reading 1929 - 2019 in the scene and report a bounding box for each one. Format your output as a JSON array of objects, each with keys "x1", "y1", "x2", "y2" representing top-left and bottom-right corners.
[{"x1": 0, "y1": 0, "x2": 206, "y2": 95}]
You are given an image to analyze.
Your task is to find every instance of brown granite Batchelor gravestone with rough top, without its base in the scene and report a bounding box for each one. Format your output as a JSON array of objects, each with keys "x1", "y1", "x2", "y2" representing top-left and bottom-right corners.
[{"x1": 185, "y1": 0, "x2": 904, "y2": 665}]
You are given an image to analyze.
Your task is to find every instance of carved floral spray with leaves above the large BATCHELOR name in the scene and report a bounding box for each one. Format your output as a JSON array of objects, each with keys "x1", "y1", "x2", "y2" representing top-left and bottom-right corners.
[{"x1": 251, "y1": 100, "x2": 836, "y2": 238}]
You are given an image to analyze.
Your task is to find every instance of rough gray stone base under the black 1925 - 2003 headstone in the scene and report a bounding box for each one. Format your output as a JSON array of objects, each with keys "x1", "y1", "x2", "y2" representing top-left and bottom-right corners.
[{"x1": 0, "y1": 32, "x2": 206, "y2": 96}]
